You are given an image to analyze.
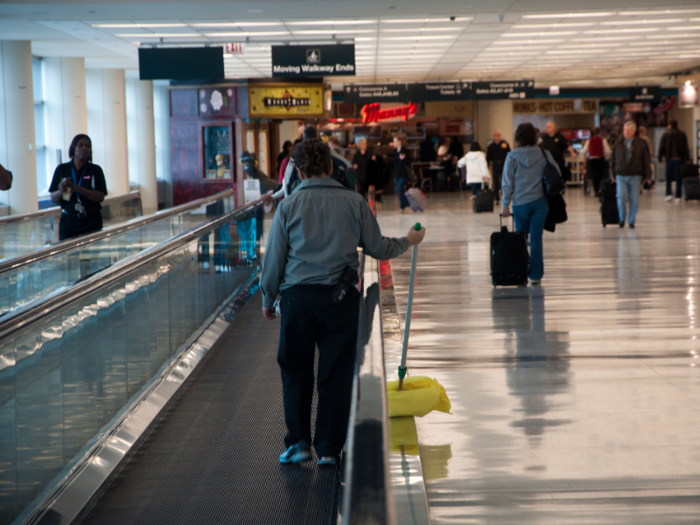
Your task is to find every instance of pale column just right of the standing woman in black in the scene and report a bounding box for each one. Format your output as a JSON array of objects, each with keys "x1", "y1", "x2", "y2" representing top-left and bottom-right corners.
[{"x1": 85, "y1": 69, "x2": 129, "y2": 196}]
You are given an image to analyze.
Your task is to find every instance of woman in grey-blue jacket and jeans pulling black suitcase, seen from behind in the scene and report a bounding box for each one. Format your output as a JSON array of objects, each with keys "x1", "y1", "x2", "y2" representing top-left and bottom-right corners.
[{"x1": 501, "y1": 122, "x2": 561, "y2": 286}]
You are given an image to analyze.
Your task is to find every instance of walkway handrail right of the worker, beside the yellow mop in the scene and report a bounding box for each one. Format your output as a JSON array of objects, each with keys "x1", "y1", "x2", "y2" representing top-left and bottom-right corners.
[{"x1": 341, "y1": 255, "x2": 396, "y2": 525}]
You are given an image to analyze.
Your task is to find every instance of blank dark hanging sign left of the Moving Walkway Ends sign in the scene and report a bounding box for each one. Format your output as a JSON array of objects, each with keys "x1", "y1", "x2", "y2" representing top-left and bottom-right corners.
[{"x1": 139, "y1": 47, "x2": 224, "y2": 80}]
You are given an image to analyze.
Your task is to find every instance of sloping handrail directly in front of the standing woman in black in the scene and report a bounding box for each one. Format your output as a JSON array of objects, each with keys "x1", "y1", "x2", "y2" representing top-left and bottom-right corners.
[{"x1": 0, "y1": 190, "x2": 234, "y2": 274}]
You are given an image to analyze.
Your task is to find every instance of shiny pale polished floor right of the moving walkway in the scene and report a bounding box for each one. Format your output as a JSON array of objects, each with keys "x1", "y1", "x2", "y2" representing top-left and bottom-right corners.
[{"x1": 378, "y1": 188, "x2": 700, "y2": 525}]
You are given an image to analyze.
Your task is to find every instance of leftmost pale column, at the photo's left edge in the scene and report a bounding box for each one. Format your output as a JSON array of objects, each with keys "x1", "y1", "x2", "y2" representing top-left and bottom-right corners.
[{"x1": 0, "y1": 41, "x2": 39, "y2": 215}]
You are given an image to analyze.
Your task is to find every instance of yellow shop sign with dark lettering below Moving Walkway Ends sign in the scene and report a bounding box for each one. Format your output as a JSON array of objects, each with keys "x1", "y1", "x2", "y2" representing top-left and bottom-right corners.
[{"x1": 248, "y1": 84, "x2": 324, "y2": 118}]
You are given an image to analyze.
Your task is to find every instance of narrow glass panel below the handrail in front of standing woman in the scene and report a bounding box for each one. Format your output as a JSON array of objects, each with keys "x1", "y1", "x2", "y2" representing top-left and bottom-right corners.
[{"x1": 0, "y1": 195, "x2": 235, "y2": 318}]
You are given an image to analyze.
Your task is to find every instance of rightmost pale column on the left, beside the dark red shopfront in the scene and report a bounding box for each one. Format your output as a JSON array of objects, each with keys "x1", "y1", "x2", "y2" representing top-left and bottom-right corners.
[{"x1": 126, "y1": 78, "x2": 158, "y2": 215}]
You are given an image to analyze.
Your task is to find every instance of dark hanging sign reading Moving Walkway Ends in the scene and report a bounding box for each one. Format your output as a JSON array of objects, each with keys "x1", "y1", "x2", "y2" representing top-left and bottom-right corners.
[{"x1": 272, "y1": 44, "x2": 355, "y2": 77}]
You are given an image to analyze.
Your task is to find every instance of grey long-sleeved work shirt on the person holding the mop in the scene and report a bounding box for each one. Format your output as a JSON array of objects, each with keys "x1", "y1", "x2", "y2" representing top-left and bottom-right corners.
[{"x1": 260, "y1": 178, "x2": 408, "y2": 307}]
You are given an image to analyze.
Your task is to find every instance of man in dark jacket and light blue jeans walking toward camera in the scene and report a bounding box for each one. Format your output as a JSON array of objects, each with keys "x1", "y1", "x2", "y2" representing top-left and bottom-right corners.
[{"x1": 611, "y1": 120, "x2": 651, "y2": 228}]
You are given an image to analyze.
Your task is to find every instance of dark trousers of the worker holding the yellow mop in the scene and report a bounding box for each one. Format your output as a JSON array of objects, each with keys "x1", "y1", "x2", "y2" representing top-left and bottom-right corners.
[{"x1": 277, "y1": 285, "x2": 360, "y2": 457}]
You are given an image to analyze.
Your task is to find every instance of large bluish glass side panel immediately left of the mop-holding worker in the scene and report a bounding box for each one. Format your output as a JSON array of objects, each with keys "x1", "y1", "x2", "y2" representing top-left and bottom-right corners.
[{"x1": 0, "y1": 208, "x2": 259, "y2": 524}]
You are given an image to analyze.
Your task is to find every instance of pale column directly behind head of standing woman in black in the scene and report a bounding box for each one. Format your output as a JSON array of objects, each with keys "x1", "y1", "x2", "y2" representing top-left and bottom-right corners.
[{"x1": 42, "y1": 58, "x2": 87, "y2": 175}]
